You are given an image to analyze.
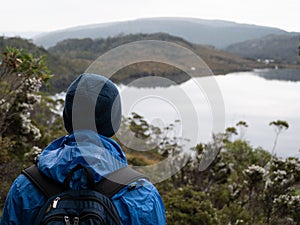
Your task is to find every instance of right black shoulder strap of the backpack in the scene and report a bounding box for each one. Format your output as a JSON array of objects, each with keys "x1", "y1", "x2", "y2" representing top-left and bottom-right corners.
[{"x1": 94, "y1": 166, "x2": 148, "y2": 198}]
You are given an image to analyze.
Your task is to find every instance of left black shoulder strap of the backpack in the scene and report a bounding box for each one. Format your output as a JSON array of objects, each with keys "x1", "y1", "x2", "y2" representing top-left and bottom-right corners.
[{"x1": 22, "y1": 164, "x2": 65, "y2": 198}]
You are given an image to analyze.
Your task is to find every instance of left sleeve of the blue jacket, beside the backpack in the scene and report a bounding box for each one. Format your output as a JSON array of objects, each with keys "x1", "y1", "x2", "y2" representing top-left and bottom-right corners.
[{"x1": 0, "y1": 175, "x2": 45, "y2": 225}]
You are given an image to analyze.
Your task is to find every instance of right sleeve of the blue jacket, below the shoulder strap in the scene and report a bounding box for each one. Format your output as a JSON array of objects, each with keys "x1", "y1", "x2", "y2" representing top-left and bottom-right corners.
[{"x1": 112, "y1": 180, "x2": 166, "y2": 225}]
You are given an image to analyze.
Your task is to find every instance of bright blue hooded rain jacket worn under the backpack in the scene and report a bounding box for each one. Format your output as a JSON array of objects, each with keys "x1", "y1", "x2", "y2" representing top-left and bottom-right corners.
[{"x1": 0, "y1": 75, "x2": 166, "y2": 225}]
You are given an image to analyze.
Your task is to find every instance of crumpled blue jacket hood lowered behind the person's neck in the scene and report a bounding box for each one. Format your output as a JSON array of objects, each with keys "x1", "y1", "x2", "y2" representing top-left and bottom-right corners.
[{"x1": 38, "y1": 130, "x2": 127, "y2": 189}]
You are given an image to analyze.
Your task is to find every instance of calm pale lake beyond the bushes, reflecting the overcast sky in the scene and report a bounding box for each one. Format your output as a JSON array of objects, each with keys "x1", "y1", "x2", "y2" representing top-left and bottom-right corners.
[{"x1": 120, "y1": 69, "x2": 300, "y2": 157}]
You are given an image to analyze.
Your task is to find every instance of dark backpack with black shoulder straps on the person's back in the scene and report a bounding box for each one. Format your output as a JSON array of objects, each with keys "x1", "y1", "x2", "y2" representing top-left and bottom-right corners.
[{"x1": 22, "y1": 164, "x2": 147, "y2": 225}]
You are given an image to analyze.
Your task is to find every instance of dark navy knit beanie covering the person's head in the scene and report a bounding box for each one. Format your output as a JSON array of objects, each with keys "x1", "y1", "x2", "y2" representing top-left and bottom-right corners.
[{"x1": 63, "y1": 74, "x2": 121, "y2": 137}]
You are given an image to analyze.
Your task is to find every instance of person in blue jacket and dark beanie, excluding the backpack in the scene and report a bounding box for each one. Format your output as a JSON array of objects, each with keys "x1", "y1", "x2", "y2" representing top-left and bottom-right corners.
[{"x1": 0, "y1": 74, "x2": 166, "y2": 225}]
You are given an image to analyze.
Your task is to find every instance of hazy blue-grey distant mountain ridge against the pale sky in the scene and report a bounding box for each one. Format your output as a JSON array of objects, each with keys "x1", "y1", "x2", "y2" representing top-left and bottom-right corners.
[{"x1": 34, "y1": 18, "x2": 288, "y2": 49}]
